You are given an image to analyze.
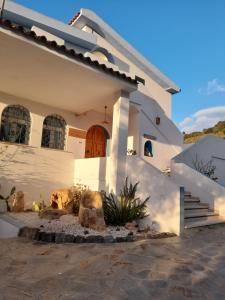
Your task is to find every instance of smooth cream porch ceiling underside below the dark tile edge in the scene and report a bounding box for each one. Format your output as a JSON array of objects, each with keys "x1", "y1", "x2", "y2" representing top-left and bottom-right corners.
[{"x1": 0, "y1": 22, "x2": 137, "y2": 114}]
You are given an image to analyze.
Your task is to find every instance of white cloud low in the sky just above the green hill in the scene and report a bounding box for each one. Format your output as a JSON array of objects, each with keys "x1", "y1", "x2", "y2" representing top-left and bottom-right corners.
[{"x1": 178, "y1": 106, "x2": 225, "y2": 133}]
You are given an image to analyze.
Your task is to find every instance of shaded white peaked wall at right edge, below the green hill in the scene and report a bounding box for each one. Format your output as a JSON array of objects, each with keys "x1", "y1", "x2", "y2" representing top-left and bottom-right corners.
[{"x1": 174, "y1": 135, "x2": 225, "y2": 186}]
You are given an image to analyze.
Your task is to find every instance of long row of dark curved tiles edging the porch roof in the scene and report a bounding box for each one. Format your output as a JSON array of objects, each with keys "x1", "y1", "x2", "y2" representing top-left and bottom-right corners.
[{"x1": 0, "y1": 18, "x2": 138, "y2": 85}]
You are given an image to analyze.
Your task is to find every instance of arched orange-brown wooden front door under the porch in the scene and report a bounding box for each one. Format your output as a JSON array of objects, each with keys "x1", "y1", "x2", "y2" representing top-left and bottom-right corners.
[{"x1": 85, "y1": 125, "x2": 108, "y2": 158}]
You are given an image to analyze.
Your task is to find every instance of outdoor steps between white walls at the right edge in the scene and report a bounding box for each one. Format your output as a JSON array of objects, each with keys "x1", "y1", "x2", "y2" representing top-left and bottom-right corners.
[{"x1": 184, "y1": 192, "x2": 225, "y2": 228}]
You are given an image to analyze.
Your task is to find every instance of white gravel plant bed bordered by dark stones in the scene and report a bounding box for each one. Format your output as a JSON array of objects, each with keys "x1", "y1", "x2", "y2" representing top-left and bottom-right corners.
[{"x1": 10, "y1": 212, "x2": 174, "y2": 243}]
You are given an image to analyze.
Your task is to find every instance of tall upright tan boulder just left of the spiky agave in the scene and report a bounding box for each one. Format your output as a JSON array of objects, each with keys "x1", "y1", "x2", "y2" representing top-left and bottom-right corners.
[{"x1": 78, "y1": 191, "x2": 106, "y2": 231}]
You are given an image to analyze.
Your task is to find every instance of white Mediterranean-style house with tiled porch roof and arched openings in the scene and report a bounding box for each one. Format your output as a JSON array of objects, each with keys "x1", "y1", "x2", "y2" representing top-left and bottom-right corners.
[{"x1": 0, "y1": 1, "x2": 225, "y2": 233}]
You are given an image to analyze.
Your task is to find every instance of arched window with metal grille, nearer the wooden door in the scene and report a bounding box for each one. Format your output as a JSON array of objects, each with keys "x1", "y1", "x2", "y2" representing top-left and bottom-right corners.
[{"x1": 41, "y1": 115, "x2": 66, "y2": 150}]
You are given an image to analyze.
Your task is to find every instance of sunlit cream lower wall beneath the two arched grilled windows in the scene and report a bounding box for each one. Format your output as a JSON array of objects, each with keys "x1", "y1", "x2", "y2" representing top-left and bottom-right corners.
[{"x1": 0, "y1": 143, "x2": 73, "y2": 206}]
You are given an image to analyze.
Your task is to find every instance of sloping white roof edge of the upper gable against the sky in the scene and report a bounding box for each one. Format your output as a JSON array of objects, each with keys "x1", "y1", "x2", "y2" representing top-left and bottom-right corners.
[{"x1": 69, "y1": 8, "x2": 181, "y2": 94}]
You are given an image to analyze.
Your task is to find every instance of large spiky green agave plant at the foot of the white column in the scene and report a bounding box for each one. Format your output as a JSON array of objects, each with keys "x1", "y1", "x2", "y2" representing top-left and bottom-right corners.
[{"x1": 103, "y1": 178, "x2": 150, "y2": 226}]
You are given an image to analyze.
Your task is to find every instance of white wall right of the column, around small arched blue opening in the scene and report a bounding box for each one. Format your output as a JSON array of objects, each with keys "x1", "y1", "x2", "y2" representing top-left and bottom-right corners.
[{"x1": 130, "y1": 91, "x2": 183, "y2": 170}]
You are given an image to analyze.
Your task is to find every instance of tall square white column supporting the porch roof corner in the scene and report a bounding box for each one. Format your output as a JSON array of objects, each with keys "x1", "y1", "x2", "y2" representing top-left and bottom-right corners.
[{"x1": 109, "y1": 91, "x2": 130, "y2": 195}]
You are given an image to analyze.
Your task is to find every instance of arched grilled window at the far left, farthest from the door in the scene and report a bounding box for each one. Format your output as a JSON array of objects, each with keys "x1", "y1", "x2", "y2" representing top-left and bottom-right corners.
[{"x1": 0, "y1": 105, "x2": 31, "y2": 144}]
